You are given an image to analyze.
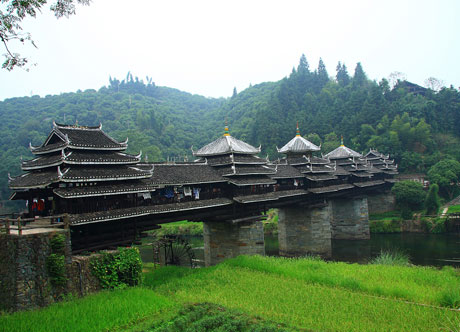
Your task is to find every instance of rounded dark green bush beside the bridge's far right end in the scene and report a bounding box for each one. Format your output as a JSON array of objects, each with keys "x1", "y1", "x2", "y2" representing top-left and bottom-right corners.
[{"x1": 391, "y1": 180, "x2": 426, "y2": 211}]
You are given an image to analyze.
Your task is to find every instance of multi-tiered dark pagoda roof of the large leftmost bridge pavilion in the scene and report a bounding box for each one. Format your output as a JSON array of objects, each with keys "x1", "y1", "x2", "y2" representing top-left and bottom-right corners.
[{"x1": 9, "y1": 122, "x2": 148, "y2": 191}]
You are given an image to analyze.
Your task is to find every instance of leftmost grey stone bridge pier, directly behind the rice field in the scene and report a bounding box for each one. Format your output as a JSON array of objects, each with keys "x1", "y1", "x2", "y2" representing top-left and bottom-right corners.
[{"x1": 203, "y1": 220, "x2": 265, "y2": 266}]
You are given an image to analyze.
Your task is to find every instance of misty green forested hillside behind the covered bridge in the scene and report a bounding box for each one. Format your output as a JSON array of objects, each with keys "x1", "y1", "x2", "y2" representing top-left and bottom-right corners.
[{"x1": 0, "y1": 56, "x2": 460, "y2": 205}]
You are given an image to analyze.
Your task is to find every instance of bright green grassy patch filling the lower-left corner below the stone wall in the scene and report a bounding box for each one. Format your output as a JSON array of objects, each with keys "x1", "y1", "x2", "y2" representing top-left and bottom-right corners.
[{"x1": 0, "y1": 287, "x2": 177, "y2": 332}]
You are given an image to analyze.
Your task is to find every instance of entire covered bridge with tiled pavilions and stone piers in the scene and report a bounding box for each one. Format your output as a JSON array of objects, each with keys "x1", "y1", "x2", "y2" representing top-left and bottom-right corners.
[{"x1": 10, "y1": 124, "x2": 396, "y2": 265}]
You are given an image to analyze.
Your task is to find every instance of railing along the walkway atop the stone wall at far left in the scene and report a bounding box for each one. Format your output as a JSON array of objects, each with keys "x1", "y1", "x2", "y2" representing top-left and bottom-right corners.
[{"x1": 0, "y1": 214, "x2": 70, "y2": 235}]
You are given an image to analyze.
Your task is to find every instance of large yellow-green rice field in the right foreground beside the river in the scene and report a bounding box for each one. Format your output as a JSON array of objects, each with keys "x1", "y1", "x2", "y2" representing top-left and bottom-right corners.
[{"x1": 146, "y1": 257, "x2": 460, "y2": 331}]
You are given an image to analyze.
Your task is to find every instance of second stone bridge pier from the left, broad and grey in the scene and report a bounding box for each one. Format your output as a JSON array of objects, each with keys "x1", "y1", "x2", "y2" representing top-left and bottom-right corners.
[{"x1": 278, "y1": 202, "x2": 332, "y2": 258}]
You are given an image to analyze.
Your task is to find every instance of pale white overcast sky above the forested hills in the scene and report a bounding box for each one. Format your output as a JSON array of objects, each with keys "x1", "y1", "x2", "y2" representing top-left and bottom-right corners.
[{"x1": 0, "y1": 0, "x2": 460, "y2": 100}]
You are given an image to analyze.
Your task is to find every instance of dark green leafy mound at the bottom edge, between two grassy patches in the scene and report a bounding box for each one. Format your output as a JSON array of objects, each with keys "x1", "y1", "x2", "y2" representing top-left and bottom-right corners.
[{"x1": 145, "y1": 303, "x2": 290, "y2": 332}]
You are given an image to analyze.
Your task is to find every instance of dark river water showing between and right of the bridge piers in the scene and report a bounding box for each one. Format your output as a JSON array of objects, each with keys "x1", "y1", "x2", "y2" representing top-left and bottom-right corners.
[{"x1": 140, "y1": 233, "x2": 460, "y2": 267}]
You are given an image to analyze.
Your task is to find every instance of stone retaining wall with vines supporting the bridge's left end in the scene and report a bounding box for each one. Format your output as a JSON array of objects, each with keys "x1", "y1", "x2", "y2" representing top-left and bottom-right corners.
[{"x1": 0, "y1": 229, "x2": 111, "y2": 311}]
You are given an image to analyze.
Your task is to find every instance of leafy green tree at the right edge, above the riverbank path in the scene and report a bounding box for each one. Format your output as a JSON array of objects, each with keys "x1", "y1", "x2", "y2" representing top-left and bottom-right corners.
[{"x1": 428, "y1": 159, "x2": 460, "y2": 199}]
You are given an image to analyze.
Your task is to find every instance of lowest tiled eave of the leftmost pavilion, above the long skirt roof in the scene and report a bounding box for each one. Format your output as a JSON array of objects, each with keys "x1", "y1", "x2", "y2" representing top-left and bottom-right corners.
[{"x1": 53, "y1": 180, "x2": 156, "y2": 198}]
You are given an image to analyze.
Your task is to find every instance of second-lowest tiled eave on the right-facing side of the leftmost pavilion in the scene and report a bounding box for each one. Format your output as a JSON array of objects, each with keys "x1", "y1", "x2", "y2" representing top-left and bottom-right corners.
[{"x1": 61, "y1": 166, "x2": 152, "y2": 182}]
